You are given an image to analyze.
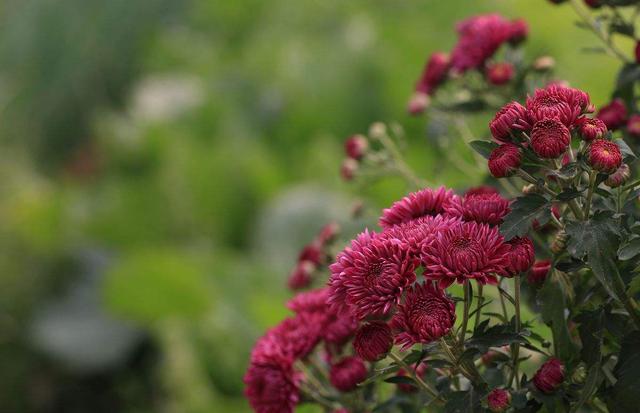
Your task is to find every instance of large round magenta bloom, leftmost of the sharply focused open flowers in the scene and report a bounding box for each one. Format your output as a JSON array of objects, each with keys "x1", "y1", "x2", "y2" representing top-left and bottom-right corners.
[{"x1": 329, "y1": 232, "x2": 418, "y2": 319}]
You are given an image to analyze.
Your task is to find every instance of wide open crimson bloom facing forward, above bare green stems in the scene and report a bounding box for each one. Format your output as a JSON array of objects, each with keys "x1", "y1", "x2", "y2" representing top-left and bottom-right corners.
[{"x1": 422, "y1": 222, "x2": 510, "y2": 288}]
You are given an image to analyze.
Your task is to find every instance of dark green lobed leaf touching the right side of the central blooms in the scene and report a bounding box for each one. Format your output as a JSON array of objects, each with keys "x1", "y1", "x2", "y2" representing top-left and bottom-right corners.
[{"x1": 500, "y1": 194, "x2": 551, "y2": 240}]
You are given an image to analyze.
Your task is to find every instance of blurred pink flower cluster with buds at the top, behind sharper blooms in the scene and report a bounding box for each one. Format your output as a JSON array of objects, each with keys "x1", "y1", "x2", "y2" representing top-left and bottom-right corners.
[{"x1": 407, "y1": 14, "x2": 529, "y2": 115}]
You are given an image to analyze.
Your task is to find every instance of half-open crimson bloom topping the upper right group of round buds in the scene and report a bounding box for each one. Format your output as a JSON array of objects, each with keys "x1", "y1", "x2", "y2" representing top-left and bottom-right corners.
[{"x1": 526, "y1": 84, "x2": 593, "y2": 127}]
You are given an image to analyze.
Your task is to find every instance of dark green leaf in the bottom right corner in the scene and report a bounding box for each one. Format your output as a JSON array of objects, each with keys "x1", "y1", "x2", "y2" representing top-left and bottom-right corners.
[{"x1": 607, "y1": 331, "x2": 640, "y2": 412}]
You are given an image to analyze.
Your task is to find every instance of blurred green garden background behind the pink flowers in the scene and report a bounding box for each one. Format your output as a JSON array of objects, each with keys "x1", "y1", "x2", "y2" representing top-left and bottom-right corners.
[{"x1": 0, "y1": 0, "x2": 616, "y2": 413}]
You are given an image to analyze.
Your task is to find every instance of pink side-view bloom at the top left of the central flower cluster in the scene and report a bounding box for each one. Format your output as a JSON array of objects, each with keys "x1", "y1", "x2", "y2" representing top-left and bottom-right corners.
[{"x1": 379, "y1": 186, "x2": 456, "y2": 228}]
